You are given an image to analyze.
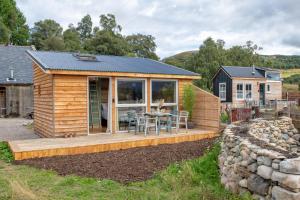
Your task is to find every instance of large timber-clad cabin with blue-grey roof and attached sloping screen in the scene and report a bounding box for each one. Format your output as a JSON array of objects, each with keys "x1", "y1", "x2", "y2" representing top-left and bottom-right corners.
[{"x1": 27, "y1": 51, "x2": 220, "y2": 137}]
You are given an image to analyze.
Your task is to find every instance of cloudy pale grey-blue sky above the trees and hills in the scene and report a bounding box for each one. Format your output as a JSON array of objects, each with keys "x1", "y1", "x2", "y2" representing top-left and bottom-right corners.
[{"x1": 16, "y1": 0, "x2": 300, "y2": 58}]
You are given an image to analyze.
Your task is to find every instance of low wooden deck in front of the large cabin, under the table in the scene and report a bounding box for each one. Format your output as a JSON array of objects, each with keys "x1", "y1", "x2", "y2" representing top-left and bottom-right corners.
[{"x1": 9, "y1": 129, "x2": 219, "y2": 160}]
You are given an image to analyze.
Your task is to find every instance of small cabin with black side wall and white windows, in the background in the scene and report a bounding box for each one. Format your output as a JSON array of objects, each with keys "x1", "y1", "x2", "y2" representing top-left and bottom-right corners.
[{"x1": 213, "y1": 66, "x2": 282, "y2": 107}]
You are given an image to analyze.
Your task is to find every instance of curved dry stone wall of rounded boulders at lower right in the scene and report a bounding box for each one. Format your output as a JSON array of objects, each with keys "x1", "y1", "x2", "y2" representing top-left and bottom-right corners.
[{"x1": 219, "y1": 117, "x2": 300, "y2": 200}]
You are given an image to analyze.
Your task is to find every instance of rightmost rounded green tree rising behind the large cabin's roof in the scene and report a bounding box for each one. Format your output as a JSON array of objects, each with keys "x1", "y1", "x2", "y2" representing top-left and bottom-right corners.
[{"x1": 126, "y1": 34, "x2": 159, "y2": 60}]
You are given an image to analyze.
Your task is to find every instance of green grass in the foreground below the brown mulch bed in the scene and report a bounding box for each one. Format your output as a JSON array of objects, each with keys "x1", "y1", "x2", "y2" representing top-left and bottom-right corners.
[{"x1": 0, "y1": 142, "x2": 251, "y2": 200}]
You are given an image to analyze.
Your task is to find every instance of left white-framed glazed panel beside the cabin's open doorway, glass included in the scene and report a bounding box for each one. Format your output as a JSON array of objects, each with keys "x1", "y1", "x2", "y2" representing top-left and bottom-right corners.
[{"x1": 116, "y1": 78, "x2": 147, "y2": 131}]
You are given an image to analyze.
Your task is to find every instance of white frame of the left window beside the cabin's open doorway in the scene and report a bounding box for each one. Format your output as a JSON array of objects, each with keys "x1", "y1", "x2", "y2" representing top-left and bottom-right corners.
[{"x1": 115, "y1": 78, "x2": 148, "y2": 133}]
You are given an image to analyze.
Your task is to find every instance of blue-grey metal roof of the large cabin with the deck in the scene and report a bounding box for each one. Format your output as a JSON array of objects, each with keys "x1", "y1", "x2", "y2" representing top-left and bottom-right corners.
[{"x1": 27, "y1": 51, "x2": 199, "y2": 76}]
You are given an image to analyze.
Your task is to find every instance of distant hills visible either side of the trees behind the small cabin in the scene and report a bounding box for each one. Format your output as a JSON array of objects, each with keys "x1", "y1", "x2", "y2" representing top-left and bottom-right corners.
[{"x1": 162, "y1": 50, "x2": 300, "y2": 69}]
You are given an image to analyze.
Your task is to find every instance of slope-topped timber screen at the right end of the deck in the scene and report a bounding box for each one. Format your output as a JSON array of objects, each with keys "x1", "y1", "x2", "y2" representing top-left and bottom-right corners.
[{"x1": 192, "y1": 86, "x2": 221, "y2": 130}]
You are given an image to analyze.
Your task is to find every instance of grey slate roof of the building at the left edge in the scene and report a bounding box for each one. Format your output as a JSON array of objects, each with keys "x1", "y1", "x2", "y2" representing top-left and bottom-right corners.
[{"x1": 0, "y1": 45, "x2": 33, "y2": 84}]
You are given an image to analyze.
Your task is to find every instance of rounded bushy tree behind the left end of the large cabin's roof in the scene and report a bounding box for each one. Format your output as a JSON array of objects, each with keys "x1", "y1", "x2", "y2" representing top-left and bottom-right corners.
[{"x1": 31, "y1": 19, "x2": 64, "y2": 51}]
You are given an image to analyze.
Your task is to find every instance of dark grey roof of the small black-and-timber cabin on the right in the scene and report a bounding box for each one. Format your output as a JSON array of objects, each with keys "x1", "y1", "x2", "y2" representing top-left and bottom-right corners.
[{"x1": 222, "y1": 66, "x2": 265, "y2": 78}]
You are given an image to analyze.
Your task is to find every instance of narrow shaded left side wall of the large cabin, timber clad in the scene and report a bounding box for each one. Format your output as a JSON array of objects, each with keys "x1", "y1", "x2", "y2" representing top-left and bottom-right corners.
[{"x1": 33, "y1": 63, "x2": 54, "y2": 137}]
